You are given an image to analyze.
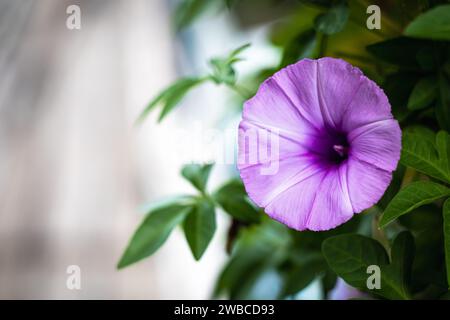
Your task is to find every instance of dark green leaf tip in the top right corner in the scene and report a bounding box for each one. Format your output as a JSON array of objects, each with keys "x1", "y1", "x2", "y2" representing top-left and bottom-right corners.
[{"x1": 404, "y1": 5, "x2": 450, "y2": 40}]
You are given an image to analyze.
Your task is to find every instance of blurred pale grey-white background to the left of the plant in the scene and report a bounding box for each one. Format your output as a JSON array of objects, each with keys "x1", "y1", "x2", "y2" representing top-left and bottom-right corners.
[{"x1": 0, "y1": 0, "x2": 279, "y2": 299}]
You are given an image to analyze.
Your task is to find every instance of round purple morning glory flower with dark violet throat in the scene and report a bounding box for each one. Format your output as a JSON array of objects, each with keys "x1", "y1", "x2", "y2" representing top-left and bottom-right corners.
[{"x1": 238, "y1": 58, "x2": 401, "y2": 230}]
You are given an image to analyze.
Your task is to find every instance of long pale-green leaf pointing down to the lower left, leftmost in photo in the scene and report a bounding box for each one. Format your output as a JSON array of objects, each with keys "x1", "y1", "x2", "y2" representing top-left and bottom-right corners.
[{"x1": 117, "y1": 204, "x2": 191, "y2": 269}]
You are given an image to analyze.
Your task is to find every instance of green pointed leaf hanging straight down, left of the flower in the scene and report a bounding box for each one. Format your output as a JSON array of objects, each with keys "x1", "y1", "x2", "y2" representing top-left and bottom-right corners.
[{"x1": 183, "y1": 198, "x2": 216, "y2": 260}]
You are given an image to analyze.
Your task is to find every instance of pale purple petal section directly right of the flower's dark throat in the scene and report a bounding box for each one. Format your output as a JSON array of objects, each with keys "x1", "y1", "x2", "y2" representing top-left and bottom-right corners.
[{"x1": 347, "y1": 119, "x2": 401, "y2": 171}]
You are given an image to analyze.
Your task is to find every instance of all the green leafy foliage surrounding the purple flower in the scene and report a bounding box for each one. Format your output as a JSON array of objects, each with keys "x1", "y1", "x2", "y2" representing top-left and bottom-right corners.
[{"x1": 118, "y1": 0, "x2": 450, "y2": 299}]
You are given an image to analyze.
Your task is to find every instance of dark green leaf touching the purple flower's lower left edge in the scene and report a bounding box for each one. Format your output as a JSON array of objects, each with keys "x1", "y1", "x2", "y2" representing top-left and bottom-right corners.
[{"x1": 213, "y1": 179, "x2": 262, "y2": 223}]
